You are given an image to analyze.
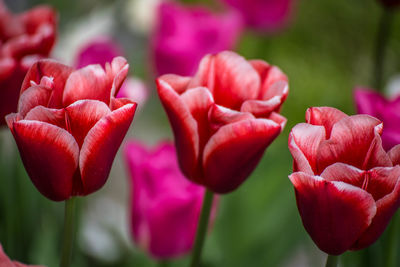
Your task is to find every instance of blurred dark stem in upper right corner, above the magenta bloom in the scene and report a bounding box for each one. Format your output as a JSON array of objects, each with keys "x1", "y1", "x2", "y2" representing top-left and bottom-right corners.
[{"x1": 373, "y1": 8, "x2": 393, "y2": 91}]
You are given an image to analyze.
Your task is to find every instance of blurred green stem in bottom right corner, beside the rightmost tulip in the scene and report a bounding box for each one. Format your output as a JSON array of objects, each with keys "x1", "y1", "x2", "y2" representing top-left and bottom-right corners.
[{"x1": 385, "y1": 212, "x2": 400, "y2": 267}]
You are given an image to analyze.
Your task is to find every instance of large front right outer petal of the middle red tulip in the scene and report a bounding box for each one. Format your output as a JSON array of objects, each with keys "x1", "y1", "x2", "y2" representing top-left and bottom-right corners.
[{"x1": 202, "y1": 119, "x2": 281, "y2": 193}]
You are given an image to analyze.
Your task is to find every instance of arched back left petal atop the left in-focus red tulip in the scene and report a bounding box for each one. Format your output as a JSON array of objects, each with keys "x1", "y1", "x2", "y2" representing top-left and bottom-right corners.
[{"x1": 21, "y1": 59, "x2": 73, "y2": 108}]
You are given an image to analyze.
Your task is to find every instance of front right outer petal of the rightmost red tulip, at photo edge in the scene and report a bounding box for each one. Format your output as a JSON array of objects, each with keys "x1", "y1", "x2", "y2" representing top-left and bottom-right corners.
[{"x1": 352, "y1": 166, "x2": 400, "y2": 250}]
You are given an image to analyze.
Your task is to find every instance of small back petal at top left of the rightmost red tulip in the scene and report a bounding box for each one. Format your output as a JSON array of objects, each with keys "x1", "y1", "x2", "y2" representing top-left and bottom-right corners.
[{"x1": 306, "y1": 107, "x2": 348, "y2": 139}]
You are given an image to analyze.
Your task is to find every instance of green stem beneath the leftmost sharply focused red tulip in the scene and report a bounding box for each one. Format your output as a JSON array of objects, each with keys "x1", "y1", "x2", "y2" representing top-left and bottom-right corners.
[{"x1": 60, "y1": 197, "x2": 75, "y2": 267}]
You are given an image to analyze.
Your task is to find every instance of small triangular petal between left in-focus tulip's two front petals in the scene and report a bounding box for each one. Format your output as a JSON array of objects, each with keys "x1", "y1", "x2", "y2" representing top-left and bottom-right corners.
[{"x1": 65, "y1": 100, "x2": 111, "y2": 147}]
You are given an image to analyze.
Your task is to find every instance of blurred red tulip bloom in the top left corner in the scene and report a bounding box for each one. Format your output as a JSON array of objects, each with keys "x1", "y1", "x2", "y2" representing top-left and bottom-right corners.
[{"x1": 0, "y1": 1, "x2": 57, "y2": 125}]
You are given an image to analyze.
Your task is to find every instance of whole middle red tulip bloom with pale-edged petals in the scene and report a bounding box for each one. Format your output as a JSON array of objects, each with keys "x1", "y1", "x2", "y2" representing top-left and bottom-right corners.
[{"x1": 157, "y1": 51, "x2": 288, "y2": 193}]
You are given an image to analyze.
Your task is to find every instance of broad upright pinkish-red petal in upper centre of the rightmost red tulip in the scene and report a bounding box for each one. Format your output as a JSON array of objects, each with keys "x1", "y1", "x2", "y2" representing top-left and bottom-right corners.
[{"x1": 317, "y1": 115, "x2": 392, "y2": 173}]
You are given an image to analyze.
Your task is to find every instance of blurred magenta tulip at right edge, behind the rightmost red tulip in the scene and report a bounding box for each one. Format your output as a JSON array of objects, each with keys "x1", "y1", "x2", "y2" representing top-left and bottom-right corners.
[{"x1": 354, "y1": 88, "x2": 400, "y2": 150}]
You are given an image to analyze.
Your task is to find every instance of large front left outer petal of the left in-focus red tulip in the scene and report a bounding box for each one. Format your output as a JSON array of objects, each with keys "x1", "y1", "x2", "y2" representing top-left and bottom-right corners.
[{"x1": 13, "y1": 120, "x2": 79, "y2": 201}]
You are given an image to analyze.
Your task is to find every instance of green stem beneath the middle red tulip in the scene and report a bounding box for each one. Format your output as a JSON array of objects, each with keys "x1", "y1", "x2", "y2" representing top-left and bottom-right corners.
[{"x1": 190, "y1": 189, "x2": 214, "y2": 267}]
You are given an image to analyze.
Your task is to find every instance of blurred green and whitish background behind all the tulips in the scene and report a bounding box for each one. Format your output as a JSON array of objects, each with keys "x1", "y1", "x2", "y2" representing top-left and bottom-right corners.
[{"x1": 0, "y1": 0, "x2": 400, "y2": 267}]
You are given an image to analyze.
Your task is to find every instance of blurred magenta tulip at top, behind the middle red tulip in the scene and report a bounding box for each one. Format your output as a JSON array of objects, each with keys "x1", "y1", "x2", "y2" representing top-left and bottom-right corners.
[{"x1": 151, "y1": 2, "x2": 242, "y2": 75}]
